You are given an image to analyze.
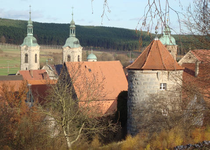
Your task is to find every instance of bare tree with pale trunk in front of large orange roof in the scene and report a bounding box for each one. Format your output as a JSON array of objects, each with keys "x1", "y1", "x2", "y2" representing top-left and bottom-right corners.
[{"x1": 39, "y1": 63, "x2": 115, "y2": 149}]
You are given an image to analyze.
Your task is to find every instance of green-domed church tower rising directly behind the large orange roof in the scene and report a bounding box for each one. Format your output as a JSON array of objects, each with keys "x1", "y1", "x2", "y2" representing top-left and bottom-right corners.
[{"x1": 63, "y1": 12, "x2": 82, "y2": 63}]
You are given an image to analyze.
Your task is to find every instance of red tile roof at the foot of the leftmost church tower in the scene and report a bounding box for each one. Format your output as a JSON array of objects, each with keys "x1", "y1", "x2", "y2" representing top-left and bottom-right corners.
[{"x1": 17, "y1": 69, "x2": 49, "y2": 80}]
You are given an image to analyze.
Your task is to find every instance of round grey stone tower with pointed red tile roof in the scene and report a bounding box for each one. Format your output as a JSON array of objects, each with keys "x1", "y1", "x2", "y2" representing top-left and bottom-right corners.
[{"x1": 127, "y1": 38, "x2": 183, "y2": 135}]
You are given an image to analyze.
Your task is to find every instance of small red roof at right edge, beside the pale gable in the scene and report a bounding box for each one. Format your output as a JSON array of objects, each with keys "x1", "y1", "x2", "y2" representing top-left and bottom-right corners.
[{"x1": 191, "y1": 49, "x2": 210, "y2": 62}]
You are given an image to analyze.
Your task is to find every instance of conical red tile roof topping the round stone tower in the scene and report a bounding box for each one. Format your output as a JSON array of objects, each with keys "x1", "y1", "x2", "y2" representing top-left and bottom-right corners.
[{"x1": 127, "y1": 40, "x2": 184, "y2": 70}]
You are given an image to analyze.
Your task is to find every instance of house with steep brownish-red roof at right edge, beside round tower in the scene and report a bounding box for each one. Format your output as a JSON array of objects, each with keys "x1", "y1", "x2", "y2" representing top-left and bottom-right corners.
[{"x1": 182, "y1": 61, "x2": 210, "y2": 126}]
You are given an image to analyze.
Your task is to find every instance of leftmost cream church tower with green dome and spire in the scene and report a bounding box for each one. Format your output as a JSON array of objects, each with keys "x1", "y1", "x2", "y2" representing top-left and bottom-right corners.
[{"x1": 20, "y1": 6, "x2": 40, "y2": 70}]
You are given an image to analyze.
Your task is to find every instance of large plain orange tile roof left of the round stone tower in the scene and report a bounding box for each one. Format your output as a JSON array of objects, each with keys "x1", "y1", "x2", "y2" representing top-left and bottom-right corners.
[{"x1": 64, "y1": 61, "x2": 128, "y2": 114}]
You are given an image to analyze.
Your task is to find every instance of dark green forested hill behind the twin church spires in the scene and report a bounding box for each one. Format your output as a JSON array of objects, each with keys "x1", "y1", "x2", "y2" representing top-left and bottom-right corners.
[{"x1": 0, "y1": 18, "x2": 154, "y2": 50}]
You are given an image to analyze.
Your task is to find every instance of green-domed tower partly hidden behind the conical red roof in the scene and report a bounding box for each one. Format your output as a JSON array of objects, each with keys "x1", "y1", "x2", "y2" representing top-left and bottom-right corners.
[{"x1": 160, "y1": 26, "x2": 177, "y2": 60}]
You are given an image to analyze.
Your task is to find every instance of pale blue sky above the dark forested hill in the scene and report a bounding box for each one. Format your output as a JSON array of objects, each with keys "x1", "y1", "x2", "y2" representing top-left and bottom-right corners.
[{"x1": 0, "y1": 0, "x2": 191, "y2": 31}]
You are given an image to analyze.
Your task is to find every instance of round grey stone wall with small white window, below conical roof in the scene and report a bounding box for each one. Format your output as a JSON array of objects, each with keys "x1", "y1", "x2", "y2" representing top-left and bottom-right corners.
[{"x1": 127, "y1": 70, "x2": 183, "y2": 135}]
